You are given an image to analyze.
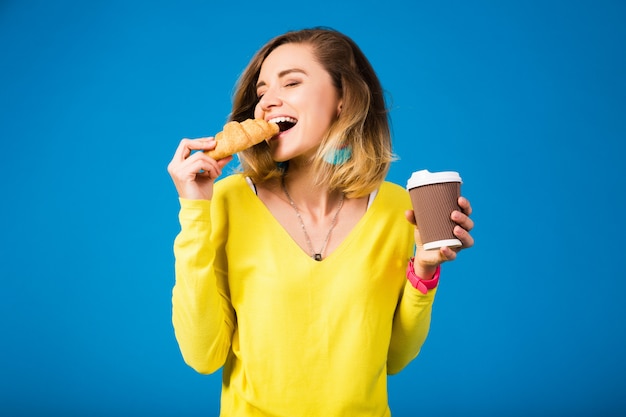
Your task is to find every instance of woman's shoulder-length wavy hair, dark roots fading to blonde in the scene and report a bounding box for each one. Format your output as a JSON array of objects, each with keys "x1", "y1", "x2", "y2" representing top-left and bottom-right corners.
[{"x1": 229, "y1": 28, "x2": 395, "y2": 198}]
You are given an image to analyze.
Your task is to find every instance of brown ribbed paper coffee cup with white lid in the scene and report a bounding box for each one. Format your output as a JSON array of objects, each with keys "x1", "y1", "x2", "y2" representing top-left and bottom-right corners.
[{"x1": 406, "y1": 170, "x2": 462, "y2": 250}]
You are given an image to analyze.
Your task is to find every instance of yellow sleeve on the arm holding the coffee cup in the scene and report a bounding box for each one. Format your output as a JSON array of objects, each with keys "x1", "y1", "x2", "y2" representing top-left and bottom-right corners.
[{"x1": 387, "y1": 281, "x2": 437, "y2": 375}]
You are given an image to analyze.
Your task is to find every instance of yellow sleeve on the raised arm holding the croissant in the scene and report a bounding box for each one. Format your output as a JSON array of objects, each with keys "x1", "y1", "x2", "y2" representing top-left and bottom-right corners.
[{"x1": 172, "y1": 199, "x2": 234, "y2": 373}]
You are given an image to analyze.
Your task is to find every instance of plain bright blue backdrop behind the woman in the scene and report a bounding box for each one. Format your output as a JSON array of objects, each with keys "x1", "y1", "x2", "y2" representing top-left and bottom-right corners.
[{"x1": 0, "y1": 0, "x2": 626, "y2": 416}]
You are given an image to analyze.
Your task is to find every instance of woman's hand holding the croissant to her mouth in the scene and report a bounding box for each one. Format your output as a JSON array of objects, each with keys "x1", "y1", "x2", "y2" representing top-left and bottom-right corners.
[{"x1": 167, "y1": 137, "x2": 233, "y2": 200}]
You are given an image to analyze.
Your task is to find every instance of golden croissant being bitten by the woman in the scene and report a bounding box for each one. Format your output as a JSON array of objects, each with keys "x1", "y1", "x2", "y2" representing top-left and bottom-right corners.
[{"x1": 205, "y1": 119, "x2": 280, "y2": 160}]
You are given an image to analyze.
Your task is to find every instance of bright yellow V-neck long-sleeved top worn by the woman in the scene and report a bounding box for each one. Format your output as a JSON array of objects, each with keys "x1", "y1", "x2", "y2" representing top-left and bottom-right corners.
[{"x1": 172, "y1": 175, "x2": 436, "y2": 417}]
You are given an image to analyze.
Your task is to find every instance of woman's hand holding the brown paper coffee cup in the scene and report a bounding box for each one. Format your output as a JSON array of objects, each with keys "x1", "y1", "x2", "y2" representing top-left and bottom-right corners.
[{"x1": 405, "y1": 197, "x2": 474, "y2": 279}]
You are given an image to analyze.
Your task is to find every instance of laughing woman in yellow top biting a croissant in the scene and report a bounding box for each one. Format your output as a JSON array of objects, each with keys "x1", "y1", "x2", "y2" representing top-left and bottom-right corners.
[{"x1": 168, "y1": 29, "x2": 473, "y2": 417}]
